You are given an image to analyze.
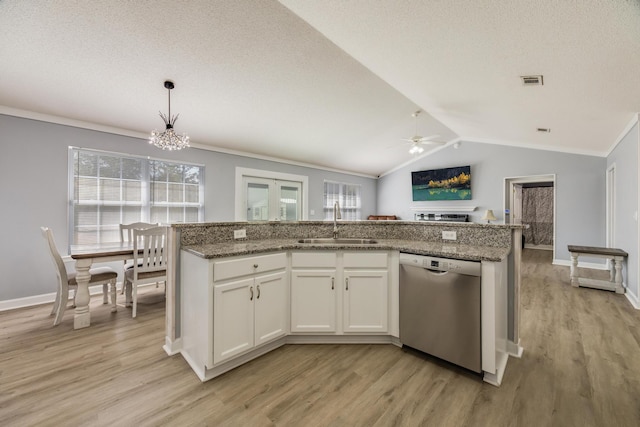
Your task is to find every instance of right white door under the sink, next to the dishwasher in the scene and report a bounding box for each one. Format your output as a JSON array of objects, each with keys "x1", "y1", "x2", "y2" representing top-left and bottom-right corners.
[{"x1": 343, "y1": 270, "x2": 389, "y2": 332}]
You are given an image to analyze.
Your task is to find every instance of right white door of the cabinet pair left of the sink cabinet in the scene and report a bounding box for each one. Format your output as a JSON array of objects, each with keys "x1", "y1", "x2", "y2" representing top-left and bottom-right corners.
[{"x1": 254, "y1": 271, "x2": 289, "y2": 345}]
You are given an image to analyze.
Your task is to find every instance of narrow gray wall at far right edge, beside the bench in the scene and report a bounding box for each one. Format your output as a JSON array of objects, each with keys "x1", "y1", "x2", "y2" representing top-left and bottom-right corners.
[{"x1": 607, "y1": 123, "x2": 640, "y2": 301}]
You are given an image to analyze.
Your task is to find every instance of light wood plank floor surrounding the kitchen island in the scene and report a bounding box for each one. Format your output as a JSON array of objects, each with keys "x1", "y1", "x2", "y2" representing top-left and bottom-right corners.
[{"x1": 0, "y1": 250, "x2": 640, "y2": 427}]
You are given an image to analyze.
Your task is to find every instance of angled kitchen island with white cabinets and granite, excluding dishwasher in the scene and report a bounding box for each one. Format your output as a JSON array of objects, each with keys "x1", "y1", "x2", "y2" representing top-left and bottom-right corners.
[{"x1": 165, "y1": 221, "x2": 521, "y2": 385}]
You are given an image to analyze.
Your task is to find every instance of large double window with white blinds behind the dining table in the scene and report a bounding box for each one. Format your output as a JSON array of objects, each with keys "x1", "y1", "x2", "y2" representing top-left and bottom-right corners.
[{"x1": 69, "y1": 147, "x2": 204, "y2": 244}]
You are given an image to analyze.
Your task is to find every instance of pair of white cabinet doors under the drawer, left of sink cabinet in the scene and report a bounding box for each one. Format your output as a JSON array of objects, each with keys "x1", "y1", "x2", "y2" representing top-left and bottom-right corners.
[{"x1": 213, "y1": 271, "x2": 289, "y2": 364}]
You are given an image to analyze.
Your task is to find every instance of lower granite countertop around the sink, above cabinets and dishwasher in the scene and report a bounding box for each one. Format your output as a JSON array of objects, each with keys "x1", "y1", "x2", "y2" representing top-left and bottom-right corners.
[{"x1": 182, "y1": 239, "x2": 511, "y2": 262}]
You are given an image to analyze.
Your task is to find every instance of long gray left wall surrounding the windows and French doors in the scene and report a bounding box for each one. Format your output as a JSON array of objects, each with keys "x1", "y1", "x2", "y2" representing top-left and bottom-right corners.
[{"x1": 0, "y1": 114, "x2": 377, "y2": 301}]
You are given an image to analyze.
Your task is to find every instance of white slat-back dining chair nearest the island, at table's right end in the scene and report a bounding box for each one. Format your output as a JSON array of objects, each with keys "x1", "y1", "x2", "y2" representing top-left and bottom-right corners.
[{"x1": 124, "y1": 227, "x2": 168, "y2": 317}]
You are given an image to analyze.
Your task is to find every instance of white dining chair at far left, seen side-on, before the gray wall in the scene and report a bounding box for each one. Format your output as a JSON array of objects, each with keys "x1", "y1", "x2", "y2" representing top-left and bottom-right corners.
[{"x1": 40, "y1": 227, "x2": 118, "y2": 326}]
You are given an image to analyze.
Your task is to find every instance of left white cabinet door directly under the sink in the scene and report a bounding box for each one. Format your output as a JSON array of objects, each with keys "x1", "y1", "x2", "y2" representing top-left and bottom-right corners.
[{"x1": 291, "y1": 269, "x2": 338, "y2": 332}]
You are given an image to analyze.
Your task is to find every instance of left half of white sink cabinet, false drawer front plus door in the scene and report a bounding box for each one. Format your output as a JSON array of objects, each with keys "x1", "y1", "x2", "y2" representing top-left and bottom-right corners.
[{"x1": 291, "y1": 252, "x2": 338, "y2": 333}]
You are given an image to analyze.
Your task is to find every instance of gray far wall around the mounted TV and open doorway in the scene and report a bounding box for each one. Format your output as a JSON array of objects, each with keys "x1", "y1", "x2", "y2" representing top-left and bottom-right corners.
[{"x1": 377, "y1": 141, "x2": 606, "y2": 261}]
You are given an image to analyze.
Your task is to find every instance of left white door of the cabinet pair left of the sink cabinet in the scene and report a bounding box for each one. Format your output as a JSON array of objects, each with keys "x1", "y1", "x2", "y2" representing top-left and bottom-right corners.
[{"x1": 215, "y1": 278, "x2": 255, "y2": 363}]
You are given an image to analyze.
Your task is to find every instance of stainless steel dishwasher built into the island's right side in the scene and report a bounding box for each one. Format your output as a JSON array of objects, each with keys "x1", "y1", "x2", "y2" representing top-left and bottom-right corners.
[{"x1": 400, "y1": 253, "x2": 482, "y2": 372}]
